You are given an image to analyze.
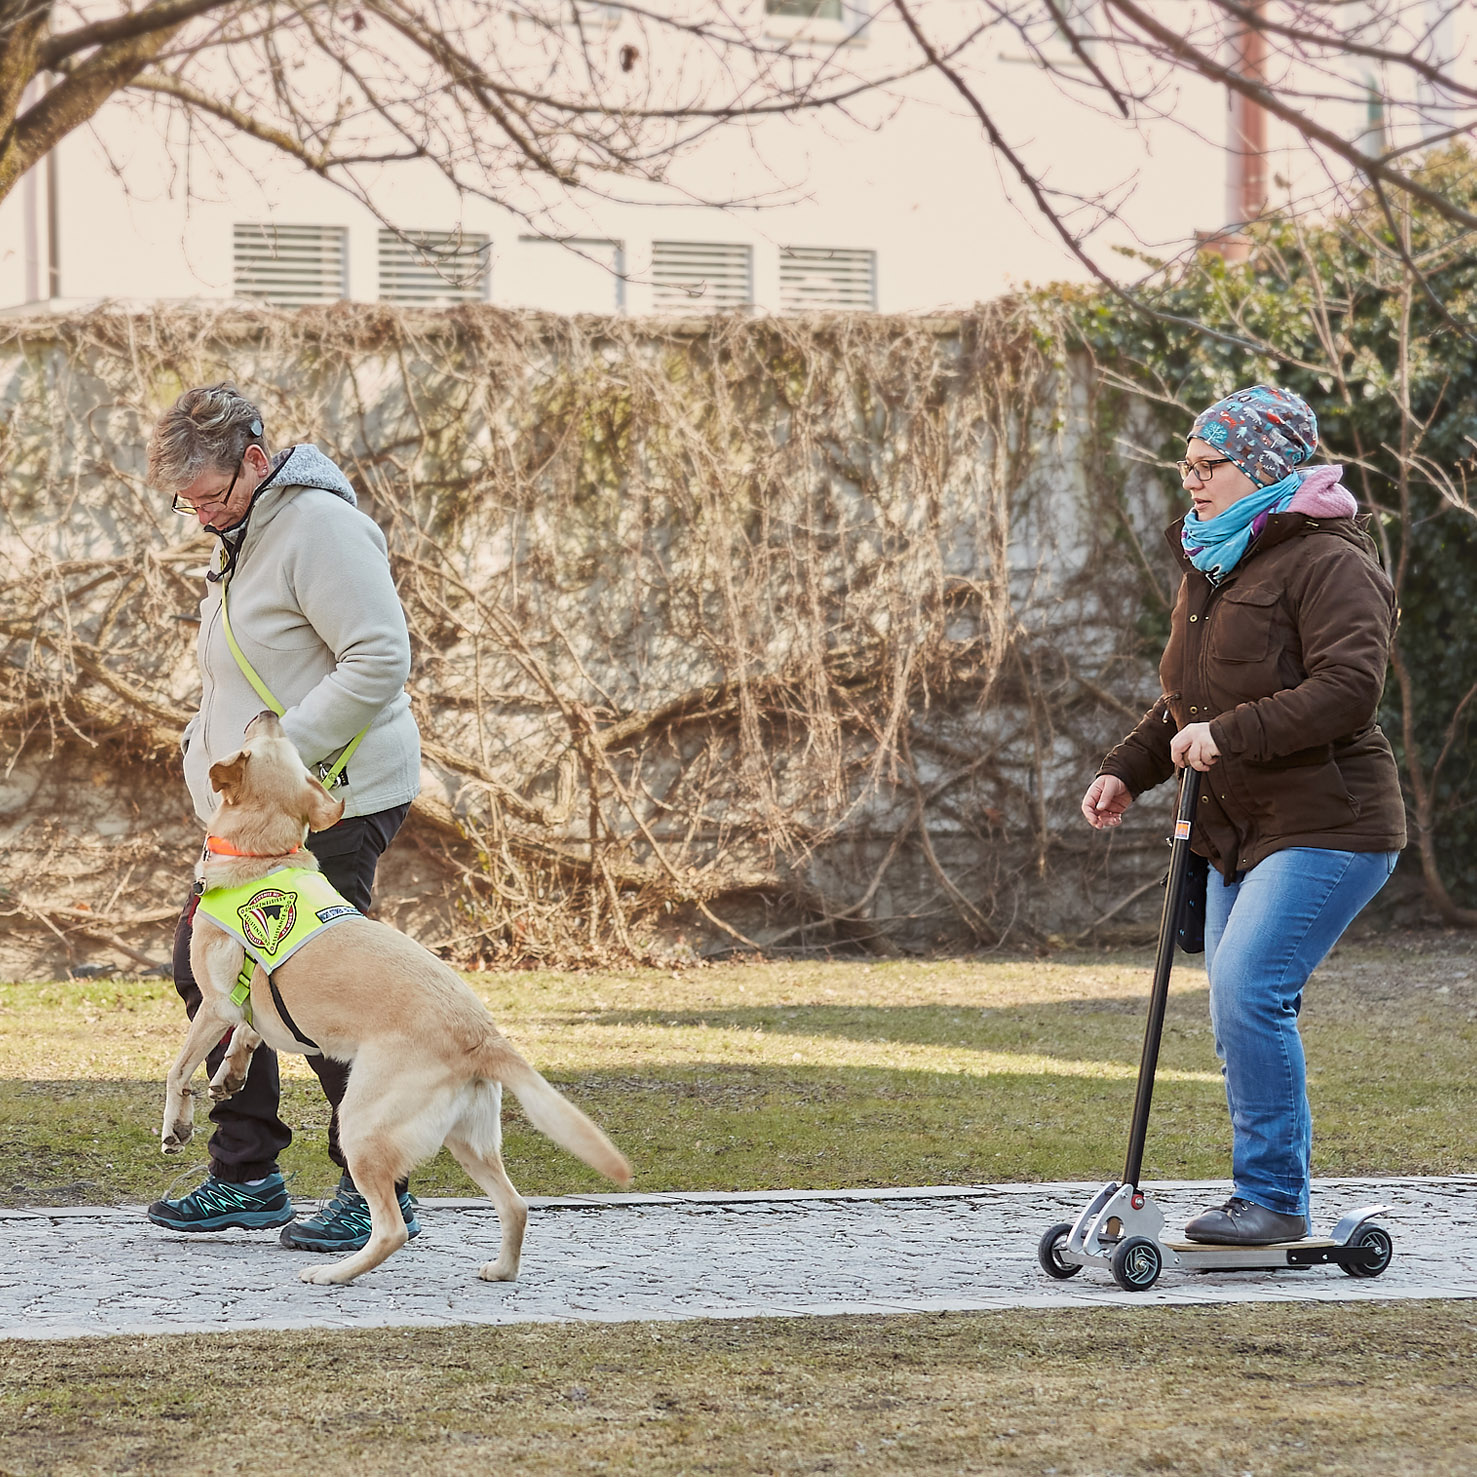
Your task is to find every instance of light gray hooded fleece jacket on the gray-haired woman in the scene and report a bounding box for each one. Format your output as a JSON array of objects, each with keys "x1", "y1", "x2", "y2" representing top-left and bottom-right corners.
[{"x1": 182, "y1": 446, "x2": 421, "y2": 824}]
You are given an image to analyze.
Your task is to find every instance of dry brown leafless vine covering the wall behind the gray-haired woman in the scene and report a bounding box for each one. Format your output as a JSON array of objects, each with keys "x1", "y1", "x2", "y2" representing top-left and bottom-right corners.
[{"x1": 0, "y1": 303, "x2": 1163, "y2": 962}]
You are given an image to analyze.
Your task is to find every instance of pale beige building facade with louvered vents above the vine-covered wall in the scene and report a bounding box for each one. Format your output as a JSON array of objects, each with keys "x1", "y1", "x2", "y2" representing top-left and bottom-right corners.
[{"x1": 0, "y1": 0, "x2": 1456, "y2": 315}]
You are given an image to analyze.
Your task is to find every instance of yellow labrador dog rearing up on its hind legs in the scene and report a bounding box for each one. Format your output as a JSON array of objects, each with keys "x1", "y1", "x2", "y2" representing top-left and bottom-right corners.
[{"x1": 162, "y1": 712, "x2": 631, "y2": 1282}]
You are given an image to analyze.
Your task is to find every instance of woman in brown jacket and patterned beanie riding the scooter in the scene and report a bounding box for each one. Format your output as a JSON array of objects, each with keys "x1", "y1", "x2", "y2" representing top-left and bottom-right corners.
[{"x1": 1083, "y1": 385, "x2": 1405, "y2": 1245}]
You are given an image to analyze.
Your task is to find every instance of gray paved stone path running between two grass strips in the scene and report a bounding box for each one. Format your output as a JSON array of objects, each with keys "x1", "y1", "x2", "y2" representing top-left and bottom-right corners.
[{"x1": 0, "y1": 1176, "x2": 1477, "y2": 1338}]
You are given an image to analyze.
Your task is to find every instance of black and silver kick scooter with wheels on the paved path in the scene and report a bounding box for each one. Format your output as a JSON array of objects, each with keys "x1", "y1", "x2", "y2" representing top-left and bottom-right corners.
[{"x1": 1037, "y1": 768, "x2": 1394, "y2": 1292}]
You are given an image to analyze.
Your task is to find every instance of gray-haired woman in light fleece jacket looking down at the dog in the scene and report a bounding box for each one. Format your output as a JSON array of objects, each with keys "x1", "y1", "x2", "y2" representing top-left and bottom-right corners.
[{"x1": 148, "y1": 384, "x2": 421, "y2": 1252}]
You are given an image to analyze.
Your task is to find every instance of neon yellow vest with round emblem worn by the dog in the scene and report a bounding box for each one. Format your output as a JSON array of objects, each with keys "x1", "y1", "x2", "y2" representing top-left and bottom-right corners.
[{"x1": 196, "y1": 867, "x2": 363, "y2": 1052}]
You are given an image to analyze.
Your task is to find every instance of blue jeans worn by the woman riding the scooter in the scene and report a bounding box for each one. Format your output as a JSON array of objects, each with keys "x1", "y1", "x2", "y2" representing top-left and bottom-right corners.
[{"x1": 1205, "y1": 846, "x2": 1400, "y2": 1216}]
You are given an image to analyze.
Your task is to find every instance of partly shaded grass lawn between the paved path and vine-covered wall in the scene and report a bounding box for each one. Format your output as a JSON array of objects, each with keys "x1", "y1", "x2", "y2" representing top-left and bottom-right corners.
[{"x1": 0, "y1": 935, "x2": 1477, "y2": 1205}]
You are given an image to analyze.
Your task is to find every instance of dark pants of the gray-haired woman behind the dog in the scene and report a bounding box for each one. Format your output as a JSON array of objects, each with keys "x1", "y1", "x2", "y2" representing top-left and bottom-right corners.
[{"x1": 174, "y1": 805, "x2": 411, "y2": 1185}]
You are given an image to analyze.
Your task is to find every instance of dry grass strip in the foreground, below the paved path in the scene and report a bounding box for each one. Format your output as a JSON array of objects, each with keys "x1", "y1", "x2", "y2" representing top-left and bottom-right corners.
[{"x1": 0, "y1": 1303, "x2": 1477, "y2": 1477}]
